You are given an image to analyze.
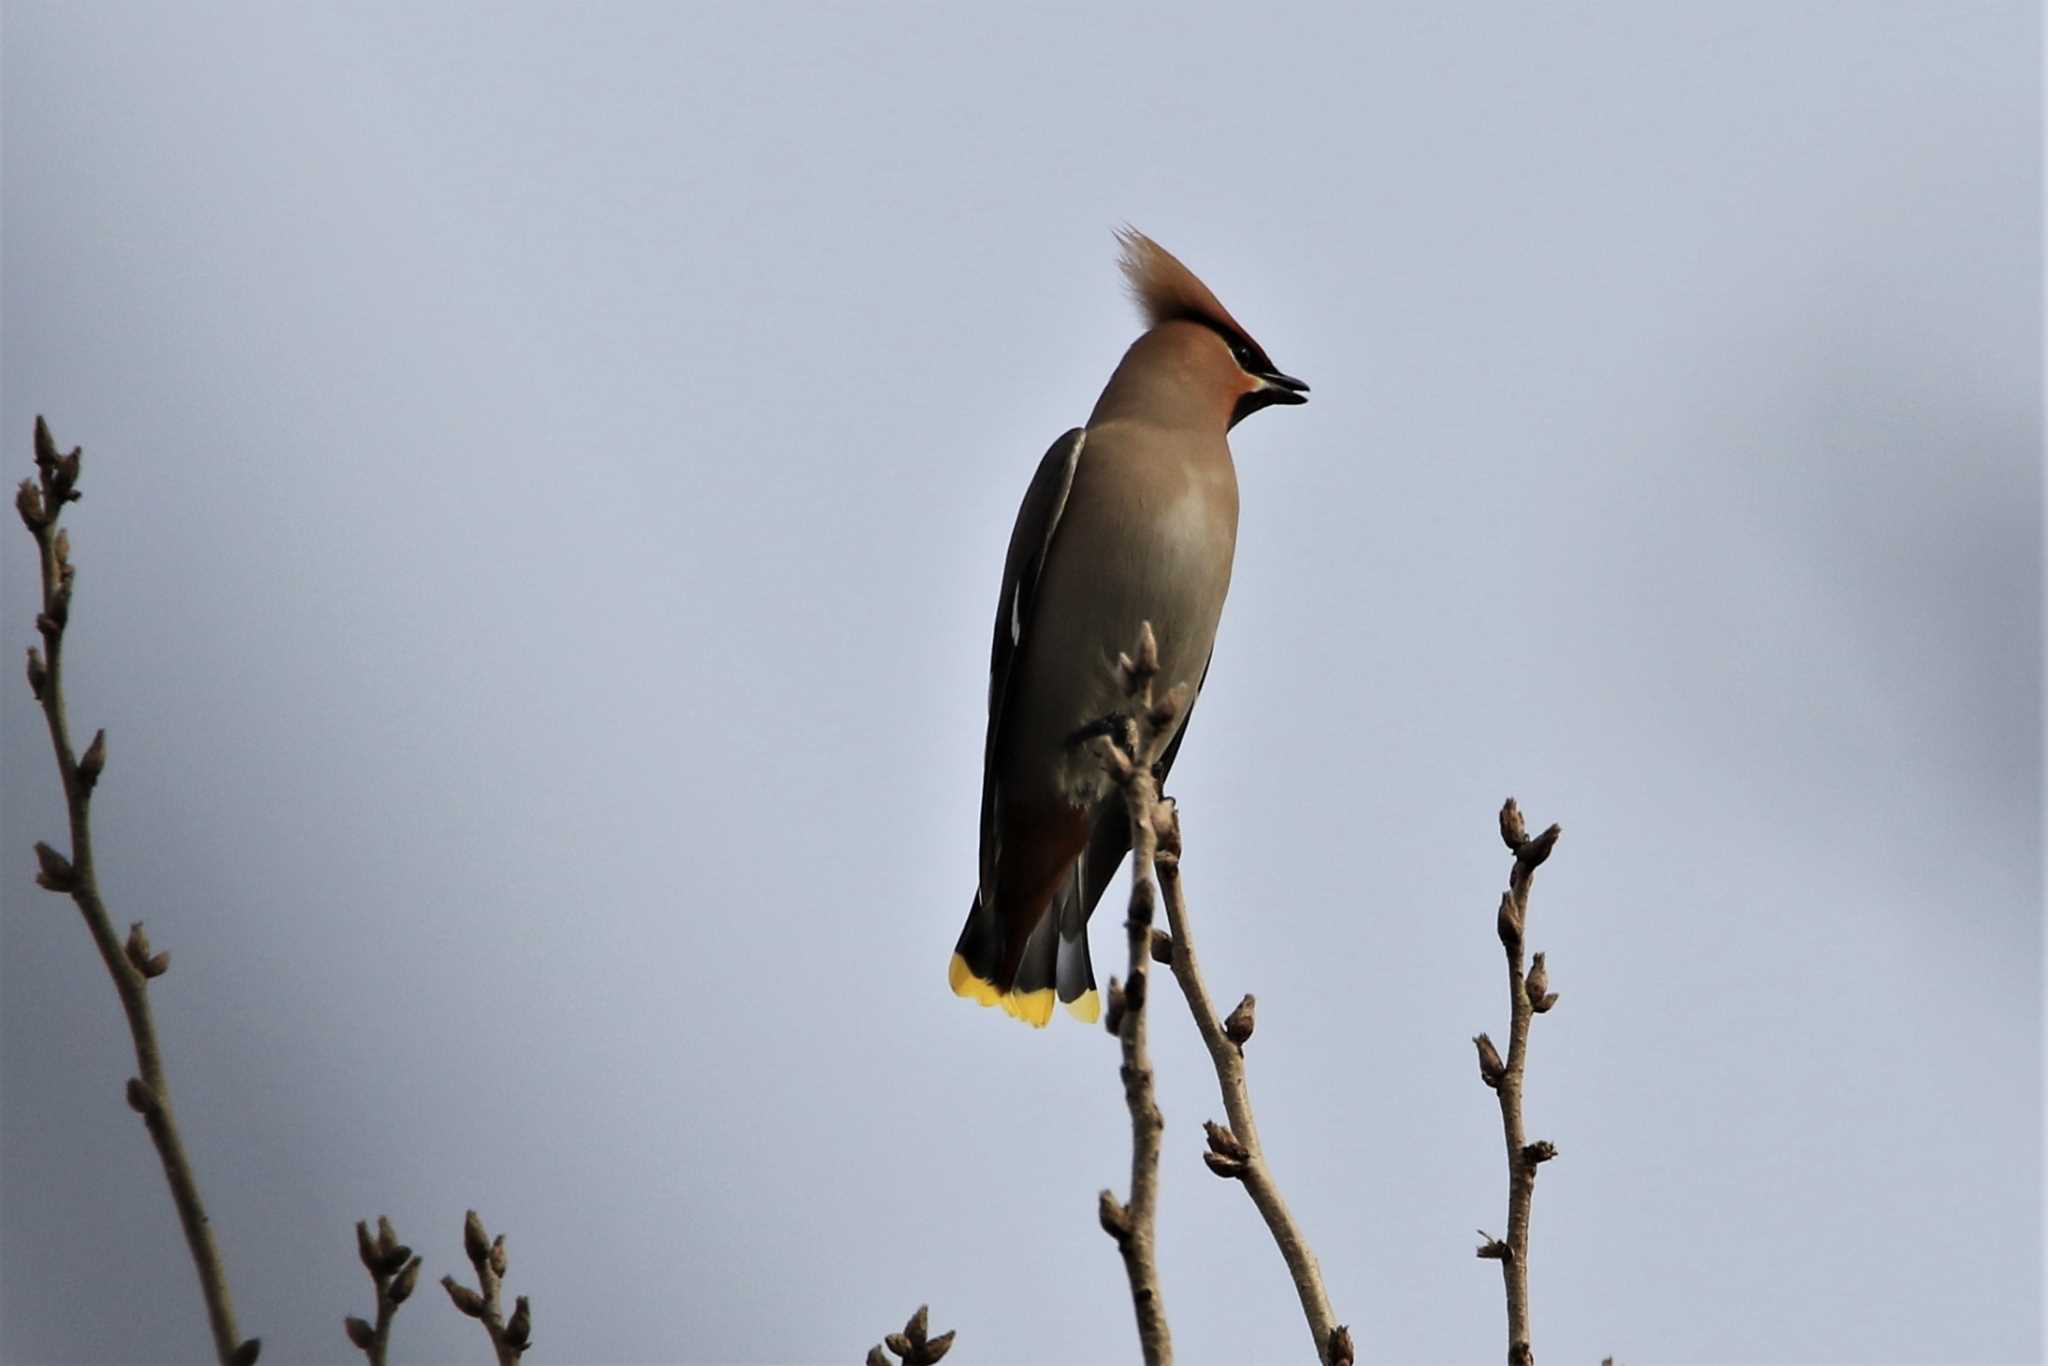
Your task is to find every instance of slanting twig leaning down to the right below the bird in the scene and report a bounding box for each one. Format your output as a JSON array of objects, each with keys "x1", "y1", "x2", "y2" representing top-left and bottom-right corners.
[{"x1": 1133, "y1": 819, "x2": 1352, "y2": 1366}]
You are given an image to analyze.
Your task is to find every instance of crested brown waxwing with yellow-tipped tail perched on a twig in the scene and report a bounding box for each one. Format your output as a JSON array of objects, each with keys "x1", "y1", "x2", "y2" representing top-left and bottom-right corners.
[{"x1": 946, "y1": 225, "x2": 1309, "y2": 1028}]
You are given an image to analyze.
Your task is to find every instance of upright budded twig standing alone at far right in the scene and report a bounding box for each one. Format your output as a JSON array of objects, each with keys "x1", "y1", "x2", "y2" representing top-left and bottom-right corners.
[{"x1": 1473, "y1": 797, "x2": 1563, "y2": 1366}]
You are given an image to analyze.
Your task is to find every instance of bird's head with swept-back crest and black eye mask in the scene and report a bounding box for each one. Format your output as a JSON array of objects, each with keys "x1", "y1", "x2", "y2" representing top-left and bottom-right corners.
[{"x1": 1116, "y1": 227, "x2": 1309, "y2": 426}]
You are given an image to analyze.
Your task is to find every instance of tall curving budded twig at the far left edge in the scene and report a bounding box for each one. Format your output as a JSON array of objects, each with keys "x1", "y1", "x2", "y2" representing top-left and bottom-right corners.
[{"x1": 14, "y1": 418, "x2": 262, "y2": 1366}]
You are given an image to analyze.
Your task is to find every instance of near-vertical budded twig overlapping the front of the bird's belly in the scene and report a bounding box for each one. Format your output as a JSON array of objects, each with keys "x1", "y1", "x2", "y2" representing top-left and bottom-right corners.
[{"x1": 1096, "y1": 623, "x2": 1186, "y2": 1366}]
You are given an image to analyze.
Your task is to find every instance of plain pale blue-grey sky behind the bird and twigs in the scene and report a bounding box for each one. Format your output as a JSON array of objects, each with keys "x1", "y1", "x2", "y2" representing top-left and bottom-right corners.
[{"x1": 0, "y1": 2, "x2": 2042, "y2": 1362}]
